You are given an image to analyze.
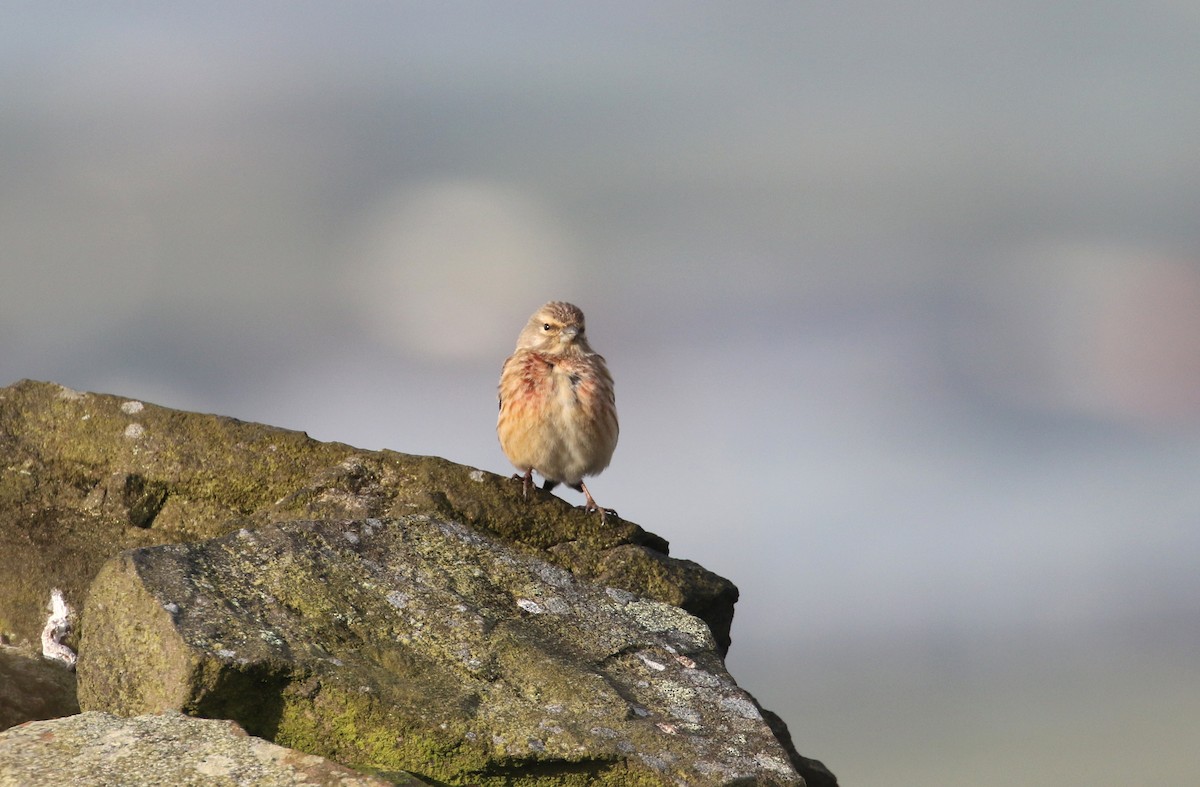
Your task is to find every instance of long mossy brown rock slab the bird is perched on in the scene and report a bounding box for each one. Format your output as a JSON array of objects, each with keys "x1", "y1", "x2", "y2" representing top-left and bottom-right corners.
[{"x1": 0, "y1": 380, "x2": 737, "y2": 651}]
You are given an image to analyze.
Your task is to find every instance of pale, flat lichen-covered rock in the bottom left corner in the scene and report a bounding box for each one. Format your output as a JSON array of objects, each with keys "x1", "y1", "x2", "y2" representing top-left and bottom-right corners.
[{"x1": 0, "y1": 711, "x2": 412, "y2": 787}]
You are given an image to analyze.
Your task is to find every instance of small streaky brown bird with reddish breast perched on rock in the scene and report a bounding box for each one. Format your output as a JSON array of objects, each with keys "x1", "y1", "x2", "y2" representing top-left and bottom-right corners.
[{"x1": 496, "y1": 301, "x2": 618, "y2": 522}]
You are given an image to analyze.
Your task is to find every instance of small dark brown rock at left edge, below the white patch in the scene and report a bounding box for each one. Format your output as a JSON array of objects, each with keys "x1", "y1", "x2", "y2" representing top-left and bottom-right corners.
[{"x1": 0, "y1": 645, "x2": 79, "y2": 729}]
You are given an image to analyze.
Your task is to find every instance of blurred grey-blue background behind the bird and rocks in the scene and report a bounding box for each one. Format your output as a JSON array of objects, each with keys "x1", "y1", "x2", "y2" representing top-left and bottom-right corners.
[{"x1": 0, "y1": 0, "x2": 1200, "y2": 787}]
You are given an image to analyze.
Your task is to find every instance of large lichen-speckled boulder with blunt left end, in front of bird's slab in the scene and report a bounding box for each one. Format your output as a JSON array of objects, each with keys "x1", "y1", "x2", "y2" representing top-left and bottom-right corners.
[{"x1": 78, "y1": 516, "x2": 803, "y2": 785}]
